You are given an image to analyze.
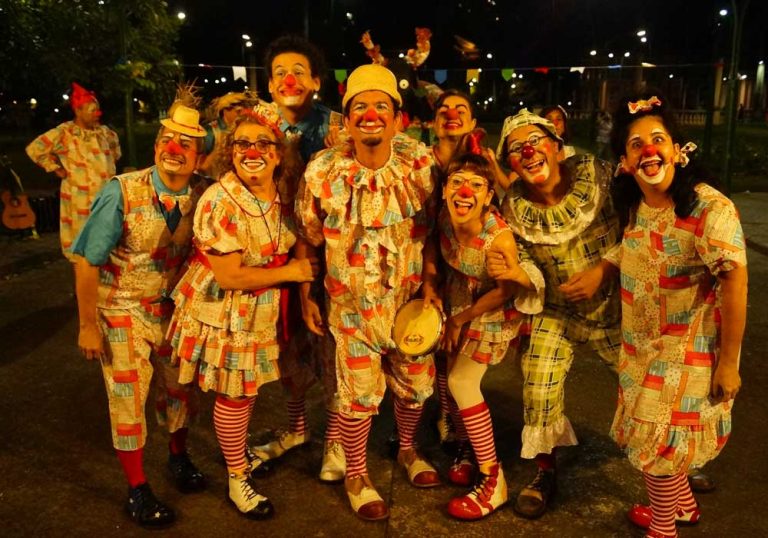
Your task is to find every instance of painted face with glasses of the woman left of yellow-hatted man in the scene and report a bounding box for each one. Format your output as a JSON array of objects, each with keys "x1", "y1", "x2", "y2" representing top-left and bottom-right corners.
[{"x1": 232, "y1": 122, "x2": 280, "y2": 186}]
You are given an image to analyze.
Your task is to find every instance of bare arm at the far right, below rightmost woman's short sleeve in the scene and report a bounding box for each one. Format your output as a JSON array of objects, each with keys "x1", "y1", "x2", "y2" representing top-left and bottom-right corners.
[{"x1": 712, "y1": 266, "x2": 747, "y2": 401}]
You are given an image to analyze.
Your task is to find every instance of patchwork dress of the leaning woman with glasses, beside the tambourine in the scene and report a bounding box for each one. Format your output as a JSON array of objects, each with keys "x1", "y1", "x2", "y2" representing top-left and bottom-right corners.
[{"x1": 438, "y1": 207, "x2": 544, "y2": 365}]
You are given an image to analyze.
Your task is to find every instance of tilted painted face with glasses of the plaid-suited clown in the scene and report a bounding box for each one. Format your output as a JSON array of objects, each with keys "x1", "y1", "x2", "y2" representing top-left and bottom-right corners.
[{"x1": 507, "y1": 125, "x2": 560, "y2": 185}]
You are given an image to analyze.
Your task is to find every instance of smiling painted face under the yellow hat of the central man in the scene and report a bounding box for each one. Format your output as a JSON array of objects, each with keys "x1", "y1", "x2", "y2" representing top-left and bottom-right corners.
[{"x1": 344, "y1": 90, "x2": 400, "y2": 147}]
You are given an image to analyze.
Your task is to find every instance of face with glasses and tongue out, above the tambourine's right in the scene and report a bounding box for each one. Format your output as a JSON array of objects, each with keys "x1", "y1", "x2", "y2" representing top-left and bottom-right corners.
[{"x1": 443, "y1": 169, "x2": 493, "y2": 226}]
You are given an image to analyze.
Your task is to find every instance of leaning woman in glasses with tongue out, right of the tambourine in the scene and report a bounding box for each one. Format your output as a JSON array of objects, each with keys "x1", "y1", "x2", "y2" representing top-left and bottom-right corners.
[{"x1": 438, "y1": 133, "x2": 544, "y2": 520}]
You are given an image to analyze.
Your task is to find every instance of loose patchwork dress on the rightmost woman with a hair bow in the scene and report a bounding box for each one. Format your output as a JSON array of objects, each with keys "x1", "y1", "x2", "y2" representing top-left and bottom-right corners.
[{"x1": 611, "y1": 184, "x2": 747, "y2": 475}]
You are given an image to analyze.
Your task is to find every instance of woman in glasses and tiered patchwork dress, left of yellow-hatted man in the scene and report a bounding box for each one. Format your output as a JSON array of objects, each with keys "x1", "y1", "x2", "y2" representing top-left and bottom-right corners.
[{"x1": 169, "y1": 103, "x2": 317, "y2": 519}]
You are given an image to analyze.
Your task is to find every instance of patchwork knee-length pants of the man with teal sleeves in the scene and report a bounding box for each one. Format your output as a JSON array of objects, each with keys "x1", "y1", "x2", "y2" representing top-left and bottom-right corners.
[{"x1": 100, "y1": 310, "x2": 198, "y2": 450}]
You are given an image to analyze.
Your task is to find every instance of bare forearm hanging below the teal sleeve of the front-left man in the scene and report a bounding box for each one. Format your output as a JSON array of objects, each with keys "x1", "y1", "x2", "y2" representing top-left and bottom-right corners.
[{"x1": 75, "y1": 256, "x2": 104, "y2": 360}]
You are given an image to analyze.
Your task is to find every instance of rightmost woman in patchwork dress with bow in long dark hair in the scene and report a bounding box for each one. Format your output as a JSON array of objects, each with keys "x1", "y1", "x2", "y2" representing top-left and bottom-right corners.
[{"x1": 611, "y1": 95, "x2": 747, "y2": 538}]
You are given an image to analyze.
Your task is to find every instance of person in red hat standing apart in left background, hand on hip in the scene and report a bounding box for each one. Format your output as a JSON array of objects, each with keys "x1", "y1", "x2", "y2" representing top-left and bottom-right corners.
[{"x1": 27, "y1": 82, "x2": 120, "y2": 263}]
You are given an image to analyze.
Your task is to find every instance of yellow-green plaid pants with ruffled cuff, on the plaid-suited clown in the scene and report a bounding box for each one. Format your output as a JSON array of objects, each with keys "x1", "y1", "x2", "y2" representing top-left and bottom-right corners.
[{"x1": 522, "y1": 310, "x2": 621, "y2": 457}]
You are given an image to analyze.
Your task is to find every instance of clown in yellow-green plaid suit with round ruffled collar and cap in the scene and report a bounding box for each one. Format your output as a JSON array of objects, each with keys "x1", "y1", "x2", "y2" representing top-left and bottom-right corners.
[{"x1": 488, "y1": 109, "x2": 621, "y2": 518}]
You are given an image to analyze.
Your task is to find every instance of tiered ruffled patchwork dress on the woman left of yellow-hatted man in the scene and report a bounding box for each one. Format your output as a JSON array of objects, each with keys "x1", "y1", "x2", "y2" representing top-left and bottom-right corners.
[{"x1": 169, "y1": 172, "x2": 296, "y2": 398}]
